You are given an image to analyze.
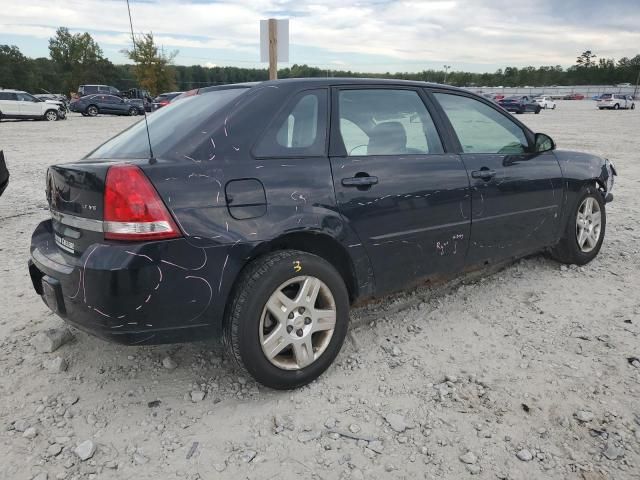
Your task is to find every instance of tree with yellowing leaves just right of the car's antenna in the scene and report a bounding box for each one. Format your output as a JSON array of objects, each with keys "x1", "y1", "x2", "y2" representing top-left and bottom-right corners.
[{"x1": 123, "y1": 33, "x2": 176, "y2": 95}]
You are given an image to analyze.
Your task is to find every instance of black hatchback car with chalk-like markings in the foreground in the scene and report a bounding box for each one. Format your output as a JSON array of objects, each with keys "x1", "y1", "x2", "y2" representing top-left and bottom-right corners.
[{"x1": 30, "y1": 78, "x2": 615, "y2": 389}]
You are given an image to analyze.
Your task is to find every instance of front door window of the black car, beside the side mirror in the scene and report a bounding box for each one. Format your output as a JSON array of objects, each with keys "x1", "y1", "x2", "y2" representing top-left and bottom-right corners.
[{"x1": 434, "y1": 93, "x2": 529, "y2": 154}]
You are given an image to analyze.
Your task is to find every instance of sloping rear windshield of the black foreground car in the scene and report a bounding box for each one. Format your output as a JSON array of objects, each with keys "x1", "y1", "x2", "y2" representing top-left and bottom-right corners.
[{"x1": 86, "y1": 88, "x2": 248, "y2": 159}]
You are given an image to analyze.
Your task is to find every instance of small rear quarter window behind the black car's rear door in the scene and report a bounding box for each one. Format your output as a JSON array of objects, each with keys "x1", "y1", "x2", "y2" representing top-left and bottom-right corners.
[{"x1": 255, "y1": 89, "x2": 327, "y2": 157}]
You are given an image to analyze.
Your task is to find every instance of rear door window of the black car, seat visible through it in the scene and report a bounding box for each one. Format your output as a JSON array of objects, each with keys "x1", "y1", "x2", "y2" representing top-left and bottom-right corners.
[{"x1": 338, "y1": 89, "x2": 443, "y2": 156}]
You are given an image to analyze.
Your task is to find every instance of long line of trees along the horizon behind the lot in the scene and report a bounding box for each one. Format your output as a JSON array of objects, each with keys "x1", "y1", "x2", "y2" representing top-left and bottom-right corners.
[{"x1": 0, "y1": 27, "x2": 640, "y2": 95}]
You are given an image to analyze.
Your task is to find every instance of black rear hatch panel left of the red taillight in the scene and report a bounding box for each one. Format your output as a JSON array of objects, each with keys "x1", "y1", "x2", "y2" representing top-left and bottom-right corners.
[{"x1": 46, "y1": 162, "x2": 110, "y2": 256}]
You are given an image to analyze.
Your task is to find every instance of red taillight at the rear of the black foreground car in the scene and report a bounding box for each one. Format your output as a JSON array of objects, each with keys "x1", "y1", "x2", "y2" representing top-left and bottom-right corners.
[{"x1": 104, "y1": 165, "x2": 181, "y2": 240}]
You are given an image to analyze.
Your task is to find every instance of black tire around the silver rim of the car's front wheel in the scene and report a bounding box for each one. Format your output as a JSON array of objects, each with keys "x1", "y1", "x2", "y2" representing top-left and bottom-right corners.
[{"x1": 551, "y1": 185, "x2": 607, "y2": 265}]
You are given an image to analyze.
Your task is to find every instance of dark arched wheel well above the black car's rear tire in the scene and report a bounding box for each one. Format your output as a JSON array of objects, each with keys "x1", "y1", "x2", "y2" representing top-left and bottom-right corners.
[{"x1": 250, "y1": 232, "x2": 358, "y2": 301}]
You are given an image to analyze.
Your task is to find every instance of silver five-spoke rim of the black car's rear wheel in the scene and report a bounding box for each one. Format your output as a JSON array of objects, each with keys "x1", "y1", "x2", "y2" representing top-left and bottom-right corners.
[{"x1": 259, "y1": 276, "x2": 336, "y2": 370}]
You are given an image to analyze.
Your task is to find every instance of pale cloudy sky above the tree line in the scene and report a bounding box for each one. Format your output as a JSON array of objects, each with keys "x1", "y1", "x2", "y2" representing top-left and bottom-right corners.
[{"x1": 0, "y1": 0, "x2": 640, "y2": 72}]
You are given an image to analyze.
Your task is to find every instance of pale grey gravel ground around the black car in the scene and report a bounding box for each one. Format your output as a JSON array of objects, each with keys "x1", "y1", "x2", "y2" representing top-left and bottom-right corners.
[{"x1": 0, "y1": 105, "x2": 640, "y2": 480}]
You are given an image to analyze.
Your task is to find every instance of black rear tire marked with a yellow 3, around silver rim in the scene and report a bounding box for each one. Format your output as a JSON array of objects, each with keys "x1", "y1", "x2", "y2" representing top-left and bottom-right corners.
[{"x1": 223, "y1": 250, "x2": 349, "y2": 390}]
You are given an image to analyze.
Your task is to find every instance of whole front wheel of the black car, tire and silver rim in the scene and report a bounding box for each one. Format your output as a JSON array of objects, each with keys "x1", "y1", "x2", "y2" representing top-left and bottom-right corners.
[{"x1": 551, "y1": 185, "x2": 607, "y2": 265}]
